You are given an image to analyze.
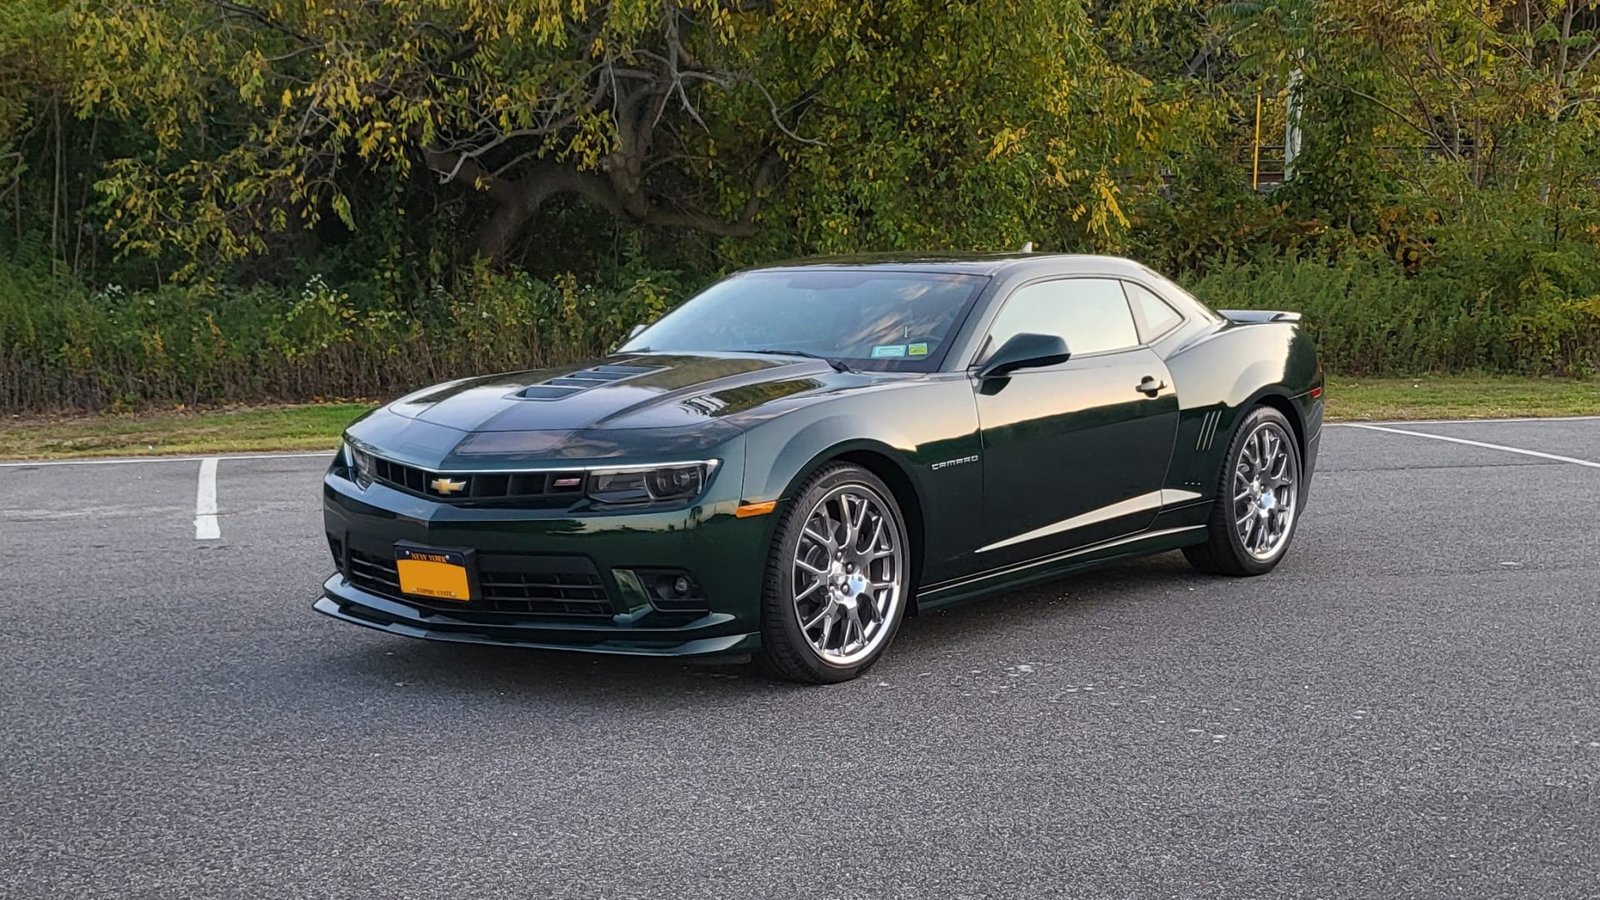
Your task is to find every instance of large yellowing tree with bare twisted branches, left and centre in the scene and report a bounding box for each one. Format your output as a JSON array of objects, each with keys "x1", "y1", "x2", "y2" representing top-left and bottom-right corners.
[{"x1": 74, "y1": 0, "x2": 1203, "y2": 269}]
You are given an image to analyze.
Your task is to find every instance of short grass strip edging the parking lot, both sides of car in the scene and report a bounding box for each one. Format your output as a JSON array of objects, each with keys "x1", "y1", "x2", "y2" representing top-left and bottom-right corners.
[{"x1": 0, "y1": 375, "x2": 1600, "y2": 460}]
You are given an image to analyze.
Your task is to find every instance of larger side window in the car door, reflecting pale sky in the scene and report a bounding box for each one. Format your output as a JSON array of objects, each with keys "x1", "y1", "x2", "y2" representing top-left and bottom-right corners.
[{"x1": 987, "y1": 279, "x2": 1139, "y2": 356}]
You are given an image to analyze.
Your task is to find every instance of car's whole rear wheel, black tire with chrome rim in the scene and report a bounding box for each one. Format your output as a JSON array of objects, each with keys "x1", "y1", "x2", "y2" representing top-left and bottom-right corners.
[{"x1": 1184, "y1": 407, "x2": 1306, "y2": 577}]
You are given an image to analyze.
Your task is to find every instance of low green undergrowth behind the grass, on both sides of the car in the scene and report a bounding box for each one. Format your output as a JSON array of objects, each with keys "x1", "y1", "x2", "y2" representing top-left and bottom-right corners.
[{"x1": 0, "y1": 241, "x2": 1600, "y2": 412}]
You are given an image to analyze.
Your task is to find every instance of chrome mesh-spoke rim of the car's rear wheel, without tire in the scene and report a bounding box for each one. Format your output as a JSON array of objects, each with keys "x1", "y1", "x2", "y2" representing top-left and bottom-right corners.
[{"x1": 1234, "y1": 421, "x2": 1299, "y2": 560}]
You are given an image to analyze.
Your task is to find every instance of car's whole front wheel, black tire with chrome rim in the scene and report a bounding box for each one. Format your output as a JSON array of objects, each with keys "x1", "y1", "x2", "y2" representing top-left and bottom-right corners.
[{"x1": 757, "y1": 463, "x2": 912, "y2": 684}]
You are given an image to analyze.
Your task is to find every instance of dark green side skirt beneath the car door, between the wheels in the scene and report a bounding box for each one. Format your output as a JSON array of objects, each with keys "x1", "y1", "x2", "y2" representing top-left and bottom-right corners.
[{"x1": 917, "y1": 503, "x2": 1210, "y2": 612}]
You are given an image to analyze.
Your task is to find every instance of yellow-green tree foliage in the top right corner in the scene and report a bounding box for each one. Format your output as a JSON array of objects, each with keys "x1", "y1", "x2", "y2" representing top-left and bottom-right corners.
[{"x1": 1222, "y1": 0, "x2": 1600, "y2": 211}]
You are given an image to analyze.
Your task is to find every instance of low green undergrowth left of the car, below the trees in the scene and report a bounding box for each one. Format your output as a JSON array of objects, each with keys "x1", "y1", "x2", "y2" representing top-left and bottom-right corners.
[{"x1": 0, "y1": 259, "x2": 683, "y2": 412}]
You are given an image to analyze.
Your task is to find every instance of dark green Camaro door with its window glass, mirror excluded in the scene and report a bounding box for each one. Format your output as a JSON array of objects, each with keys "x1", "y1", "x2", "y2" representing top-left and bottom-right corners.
[{"x1": 973, "y1": 279, "x2": 1178, "y2": 569}]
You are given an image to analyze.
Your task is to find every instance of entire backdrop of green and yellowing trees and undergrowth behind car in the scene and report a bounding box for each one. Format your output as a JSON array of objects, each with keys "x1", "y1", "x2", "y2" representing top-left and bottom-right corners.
[{"x1": 0, "y1": 0, "x2": 1600, "y2": 408}]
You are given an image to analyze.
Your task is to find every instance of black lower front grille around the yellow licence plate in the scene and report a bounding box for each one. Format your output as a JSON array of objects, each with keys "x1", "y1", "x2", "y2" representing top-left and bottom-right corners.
[{"x1": 346, "y1": 548, "x2": 614, "y2": 617}]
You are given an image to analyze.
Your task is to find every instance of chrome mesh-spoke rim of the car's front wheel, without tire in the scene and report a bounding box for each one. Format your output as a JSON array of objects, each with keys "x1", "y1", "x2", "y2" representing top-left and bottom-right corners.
[{"x1": 794, "y1": 484, "x2": 906, "y2": 666}]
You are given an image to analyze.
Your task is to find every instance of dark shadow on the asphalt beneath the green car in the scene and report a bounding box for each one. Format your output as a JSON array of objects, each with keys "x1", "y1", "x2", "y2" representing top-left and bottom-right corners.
[{"x1": 328, "y1": 554, "x2": 1198, "y2": 703}]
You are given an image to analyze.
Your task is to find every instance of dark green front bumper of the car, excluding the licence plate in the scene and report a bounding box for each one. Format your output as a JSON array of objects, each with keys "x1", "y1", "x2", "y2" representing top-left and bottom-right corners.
[{"x1": 314, "y1": 472, "x2": 774, "y2": 657}]
